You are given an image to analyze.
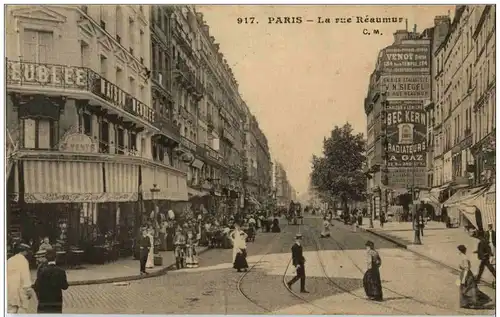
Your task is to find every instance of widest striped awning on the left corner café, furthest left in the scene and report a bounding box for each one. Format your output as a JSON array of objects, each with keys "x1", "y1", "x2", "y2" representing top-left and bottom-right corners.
[{"x1": 23, "y1": 160, "x2": 105, "y2": 203}]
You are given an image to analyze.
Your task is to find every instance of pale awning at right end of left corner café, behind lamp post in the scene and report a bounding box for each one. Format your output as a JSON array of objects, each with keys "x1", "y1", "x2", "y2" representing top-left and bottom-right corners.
[{"x1": 141, "y1": 166, "x2": 188, "y2": 201}]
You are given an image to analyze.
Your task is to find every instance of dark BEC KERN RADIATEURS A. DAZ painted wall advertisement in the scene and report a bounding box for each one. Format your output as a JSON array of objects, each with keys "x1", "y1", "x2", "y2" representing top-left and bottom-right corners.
[{"x1": 386, "y1": 100, "x2": 427, "y2": 167}]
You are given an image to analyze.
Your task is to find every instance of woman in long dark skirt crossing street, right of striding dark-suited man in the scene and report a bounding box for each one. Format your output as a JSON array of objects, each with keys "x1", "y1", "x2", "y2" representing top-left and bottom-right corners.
[{"x1": 363, "y1": 241, "x2": 383, "y2": 301}]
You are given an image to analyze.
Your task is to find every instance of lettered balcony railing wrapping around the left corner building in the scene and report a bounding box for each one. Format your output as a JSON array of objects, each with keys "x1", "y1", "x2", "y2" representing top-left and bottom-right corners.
[{"x1": 7, "y1": 60, "x2": 156, "y2": 124}]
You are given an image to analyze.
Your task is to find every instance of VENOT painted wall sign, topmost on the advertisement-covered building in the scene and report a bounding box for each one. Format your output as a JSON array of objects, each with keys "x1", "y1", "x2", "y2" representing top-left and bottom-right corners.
[{"x1": 380, "y1": 44, "x2": 431, "y2": 74}]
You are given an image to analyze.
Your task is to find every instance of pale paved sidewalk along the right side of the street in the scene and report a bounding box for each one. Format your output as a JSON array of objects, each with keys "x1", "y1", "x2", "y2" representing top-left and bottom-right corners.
[{"x1": 361, "y1": 218, "x2": 494, "y2": 283}]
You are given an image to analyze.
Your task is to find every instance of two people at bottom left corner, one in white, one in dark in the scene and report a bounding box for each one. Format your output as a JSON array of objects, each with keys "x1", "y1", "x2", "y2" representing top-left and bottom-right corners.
[{"x1": 7, "y1": 243, "x2": 69, "y2": 314}]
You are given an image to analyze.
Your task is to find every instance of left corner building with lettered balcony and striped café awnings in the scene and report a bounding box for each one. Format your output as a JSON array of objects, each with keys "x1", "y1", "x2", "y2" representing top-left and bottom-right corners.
[{"x1": 6, "y1": 5, "x2": 187, "y2": 250}]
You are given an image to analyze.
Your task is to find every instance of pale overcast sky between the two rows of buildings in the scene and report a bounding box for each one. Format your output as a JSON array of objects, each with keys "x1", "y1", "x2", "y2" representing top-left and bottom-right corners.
[{"x1": 196, "y1": 5, "x2": 455, "y2": 195}]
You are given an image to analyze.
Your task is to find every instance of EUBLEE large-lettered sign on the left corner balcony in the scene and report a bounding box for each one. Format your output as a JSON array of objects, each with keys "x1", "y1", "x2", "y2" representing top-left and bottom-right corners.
[{"x1": 7, "y1": 61, "x2": 88, "y2": 89}]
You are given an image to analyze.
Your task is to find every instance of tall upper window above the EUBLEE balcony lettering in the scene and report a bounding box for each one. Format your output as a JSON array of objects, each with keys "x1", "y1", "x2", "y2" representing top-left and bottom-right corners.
[{"x1": 22, "y1": 29, "x2": 54, "y2": 63}]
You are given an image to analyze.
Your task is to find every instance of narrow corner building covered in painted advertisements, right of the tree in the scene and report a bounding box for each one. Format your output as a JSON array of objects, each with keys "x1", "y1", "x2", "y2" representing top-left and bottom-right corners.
[{"x1": 365, "y1": 18, "x2": 450, "y2": 217}]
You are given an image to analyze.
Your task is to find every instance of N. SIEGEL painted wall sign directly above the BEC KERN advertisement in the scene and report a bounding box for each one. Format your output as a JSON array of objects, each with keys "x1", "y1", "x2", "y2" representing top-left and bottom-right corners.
[{"x1": 381, "y1": 75, "x2": 431, "y2": 99}]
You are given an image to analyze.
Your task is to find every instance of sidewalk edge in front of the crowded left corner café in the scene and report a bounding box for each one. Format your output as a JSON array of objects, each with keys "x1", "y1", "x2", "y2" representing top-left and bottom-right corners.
[{"x1": 31, "y1": 247, "x2": 208, "y2": 285}]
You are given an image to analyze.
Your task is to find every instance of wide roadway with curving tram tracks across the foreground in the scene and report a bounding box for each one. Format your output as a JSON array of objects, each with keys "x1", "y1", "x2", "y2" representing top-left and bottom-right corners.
[{"x1": 45, "y1": 217, "x2": 494, "y2": 315}]
